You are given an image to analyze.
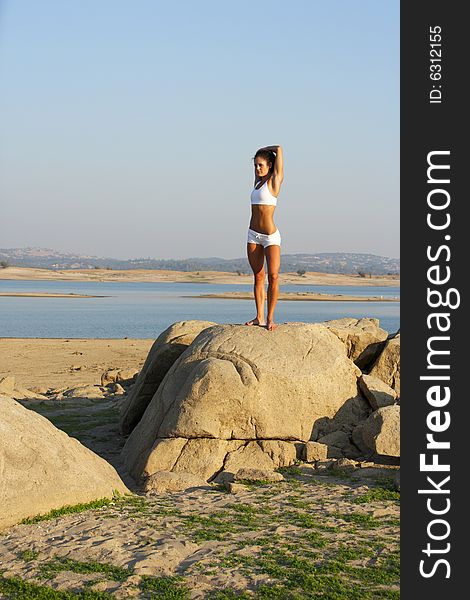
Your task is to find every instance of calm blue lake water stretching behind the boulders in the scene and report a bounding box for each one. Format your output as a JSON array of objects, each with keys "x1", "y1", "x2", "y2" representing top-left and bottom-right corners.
[{"x1": 0, "y1": 280, "x2": 400, "y2": 338}]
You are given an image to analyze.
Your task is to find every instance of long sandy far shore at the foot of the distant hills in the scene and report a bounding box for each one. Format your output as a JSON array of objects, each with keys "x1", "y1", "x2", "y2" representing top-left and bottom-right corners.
[{"x1": 0, "y1": 267, "x2": 400, "y2": 286}]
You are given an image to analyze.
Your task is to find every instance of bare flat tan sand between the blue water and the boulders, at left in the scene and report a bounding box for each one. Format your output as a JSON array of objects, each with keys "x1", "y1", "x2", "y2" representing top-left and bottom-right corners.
[{"x1": 0, "y1": 338, "x2": 155, "y2": 388}]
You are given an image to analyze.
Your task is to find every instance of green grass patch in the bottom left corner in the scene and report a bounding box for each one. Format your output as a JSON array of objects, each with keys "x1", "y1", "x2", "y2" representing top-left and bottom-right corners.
[{"x1": 0, "y1": 575, "x2": 114, "y2": 600}]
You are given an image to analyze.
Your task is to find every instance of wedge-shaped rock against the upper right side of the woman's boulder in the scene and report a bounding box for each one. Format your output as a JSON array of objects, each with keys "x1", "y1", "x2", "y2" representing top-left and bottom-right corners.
[{"x1": 325, "y1": 317, "x2": 388, "y2": 370}]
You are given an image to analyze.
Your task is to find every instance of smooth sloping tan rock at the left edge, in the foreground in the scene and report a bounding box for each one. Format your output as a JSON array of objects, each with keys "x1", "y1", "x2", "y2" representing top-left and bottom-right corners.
[{"x1": 0, "y1": 397, "x2": 129, "y2": 529}]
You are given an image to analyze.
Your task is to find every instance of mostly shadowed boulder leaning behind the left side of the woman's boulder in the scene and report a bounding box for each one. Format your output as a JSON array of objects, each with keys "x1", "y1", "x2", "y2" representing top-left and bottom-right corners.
[{"x1": 120, "y1": 321, "x2": 215, "y2": 435}]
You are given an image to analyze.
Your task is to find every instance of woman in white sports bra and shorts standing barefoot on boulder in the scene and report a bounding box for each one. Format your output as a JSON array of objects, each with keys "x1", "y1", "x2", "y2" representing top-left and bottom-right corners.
[{"x1": 245, "y1": 146, "x2": 284, "y2": 331}]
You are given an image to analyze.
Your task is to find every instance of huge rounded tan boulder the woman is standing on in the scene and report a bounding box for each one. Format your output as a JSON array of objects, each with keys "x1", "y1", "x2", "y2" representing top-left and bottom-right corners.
[{"x1": 123, "y1": 323, "x2": 361, "y2": 479}]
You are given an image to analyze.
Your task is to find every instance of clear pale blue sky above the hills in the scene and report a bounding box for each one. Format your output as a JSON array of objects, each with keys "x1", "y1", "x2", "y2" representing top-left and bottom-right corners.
[{"x1": 0, "y1": 0, "x2": 399, "y2": 258}]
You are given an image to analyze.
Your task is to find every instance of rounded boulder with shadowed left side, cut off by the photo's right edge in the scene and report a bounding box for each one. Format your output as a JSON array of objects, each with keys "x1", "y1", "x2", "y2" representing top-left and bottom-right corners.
[{"x1": 359, "y1": 404, "x2": 400, "y2": 457}]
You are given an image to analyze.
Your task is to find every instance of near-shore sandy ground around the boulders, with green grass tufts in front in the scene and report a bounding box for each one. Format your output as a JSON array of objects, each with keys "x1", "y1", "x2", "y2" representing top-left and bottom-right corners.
[{"x1": 0, "y1": 339, "x2": 399, "y2": 600}]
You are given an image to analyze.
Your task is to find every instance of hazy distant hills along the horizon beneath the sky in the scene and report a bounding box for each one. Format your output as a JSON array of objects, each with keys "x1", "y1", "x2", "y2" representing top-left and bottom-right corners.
[{"x1": 0, "y1": 248, "x2": 400, "y2": 275}]
